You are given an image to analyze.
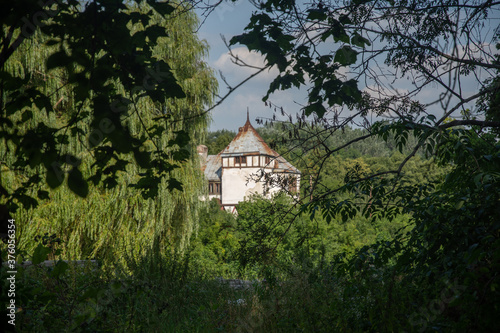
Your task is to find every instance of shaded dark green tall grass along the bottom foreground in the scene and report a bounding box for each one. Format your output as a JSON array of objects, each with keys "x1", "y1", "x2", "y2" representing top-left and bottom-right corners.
[{"x1": 1, "y1": 241, "x2": 459, "y2": 332}]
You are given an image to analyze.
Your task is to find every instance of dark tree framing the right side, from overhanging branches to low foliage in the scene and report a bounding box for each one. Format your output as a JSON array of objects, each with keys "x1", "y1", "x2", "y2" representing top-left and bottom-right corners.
[{"x1": 230, "y1": 0, "x2": 500, "y2": 330}]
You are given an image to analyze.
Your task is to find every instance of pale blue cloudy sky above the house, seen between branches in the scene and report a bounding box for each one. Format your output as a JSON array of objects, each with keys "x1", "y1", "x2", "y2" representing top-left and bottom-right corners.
[{"x1": 197, "y1": 0, "x2": 500, "y2": 131}]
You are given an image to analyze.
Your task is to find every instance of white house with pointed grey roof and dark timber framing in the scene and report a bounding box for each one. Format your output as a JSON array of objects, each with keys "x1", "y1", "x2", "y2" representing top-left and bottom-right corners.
[{"x1": 198, "y1": 113, "x2": 300, "y2": 212}]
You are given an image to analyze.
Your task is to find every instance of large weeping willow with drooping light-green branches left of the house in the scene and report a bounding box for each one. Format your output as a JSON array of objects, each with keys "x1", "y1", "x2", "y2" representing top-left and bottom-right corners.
[{"x1": 0, "y1": 0, "x2": 217, "y2": 259}]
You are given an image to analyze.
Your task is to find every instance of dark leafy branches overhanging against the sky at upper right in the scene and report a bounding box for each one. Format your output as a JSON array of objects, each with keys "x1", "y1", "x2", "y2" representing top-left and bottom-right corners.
[{"x1": 230, "y1": 0, "x2": 500, "y2": 237}]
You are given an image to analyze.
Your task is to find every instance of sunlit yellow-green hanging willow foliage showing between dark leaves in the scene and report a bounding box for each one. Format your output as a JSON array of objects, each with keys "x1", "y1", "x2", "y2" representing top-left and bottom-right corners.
[{"x1": 0, "y1": 1, "x2": 217, "y2": 263}]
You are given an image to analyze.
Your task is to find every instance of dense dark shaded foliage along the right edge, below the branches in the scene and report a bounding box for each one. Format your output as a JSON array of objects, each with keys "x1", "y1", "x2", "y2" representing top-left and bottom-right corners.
[{"x1": 403, "y1": 130, "x2": 500, "y2": 330}]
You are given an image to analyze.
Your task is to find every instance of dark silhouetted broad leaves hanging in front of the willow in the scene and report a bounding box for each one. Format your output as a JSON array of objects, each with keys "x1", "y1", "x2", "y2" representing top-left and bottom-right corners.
[{"x1": 0, "y1": 0, "x2": 212, "y2": 211}]
